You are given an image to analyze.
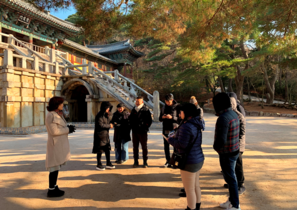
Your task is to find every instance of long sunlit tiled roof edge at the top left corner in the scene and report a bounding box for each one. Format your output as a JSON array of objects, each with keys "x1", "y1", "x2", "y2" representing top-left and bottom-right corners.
[{"x1": 1, "y1": 0, "x2": 83, "y2": 32}]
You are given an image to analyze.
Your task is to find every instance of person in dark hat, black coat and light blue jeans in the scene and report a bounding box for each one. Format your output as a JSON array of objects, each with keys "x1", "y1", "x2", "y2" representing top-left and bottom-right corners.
[{"x1": 110, "y1": 103, "x2": 131, "y2": 164}]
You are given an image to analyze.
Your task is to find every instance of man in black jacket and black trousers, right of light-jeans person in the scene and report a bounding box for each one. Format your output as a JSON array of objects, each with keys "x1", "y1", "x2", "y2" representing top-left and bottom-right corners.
[{"x1": 129, "y1": 97, "x2": 152, "y2": 168}]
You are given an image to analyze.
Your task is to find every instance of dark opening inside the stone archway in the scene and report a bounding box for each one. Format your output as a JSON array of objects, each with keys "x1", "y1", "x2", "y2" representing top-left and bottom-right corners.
[{"x1": 71, "y1": 85, "x2": 89, "y2": 122}]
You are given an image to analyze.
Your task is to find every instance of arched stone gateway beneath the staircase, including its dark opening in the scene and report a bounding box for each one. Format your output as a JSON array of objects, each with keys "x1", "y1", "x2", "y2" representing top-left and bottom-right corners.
[{"x1": 61, "y1": 78, "x2": 100, "y2": 122}]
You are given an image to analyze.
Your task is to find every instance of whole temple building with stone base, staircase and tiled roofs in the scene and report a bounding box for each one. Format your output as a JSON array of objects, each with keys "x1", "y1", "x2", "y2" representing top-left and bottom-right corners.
[{"x1": 0, "y1": 0, "x2": 160, "y2": 134}]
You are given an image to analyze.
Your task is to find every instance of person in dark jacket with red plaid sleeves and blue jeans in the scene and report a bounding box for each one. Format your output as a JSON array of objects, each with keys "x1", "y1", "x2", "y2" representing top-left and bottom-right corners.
[{"x1": 213, "y1": 93, "x2": 240, "y2": 210}]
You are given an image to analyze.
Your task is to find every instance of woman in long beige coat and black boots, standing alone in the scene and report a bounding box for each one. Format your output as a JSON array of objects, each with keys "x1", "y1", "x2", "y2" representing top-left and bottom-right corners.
[{"x1": 45, "y1": 97, "x2": 75, "y2": 197}]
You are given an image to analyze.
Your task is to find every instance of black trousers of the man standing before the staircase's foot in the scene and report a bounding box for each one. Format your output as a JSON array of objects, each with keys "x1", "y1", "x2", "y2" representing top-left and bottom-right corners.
[{"x1": 132, "y1": 132, "x2": 148, "y2": 161}]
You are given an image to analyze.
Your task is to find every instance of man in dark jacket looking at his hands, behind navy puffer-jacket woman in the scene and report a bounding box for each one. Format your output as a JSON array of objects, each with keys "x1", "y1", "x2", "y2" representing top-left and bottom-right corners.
[{"x1": 159, "y1": 94, "x2": 179, "y2": 168}]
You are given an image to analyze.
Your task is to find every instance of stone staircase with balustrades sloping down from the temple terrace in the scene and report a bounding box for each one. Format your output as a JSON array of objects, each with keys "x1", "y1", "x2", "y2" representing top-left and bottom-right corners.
[{"x1": 1, "y1": 34, "x2": 165, "y2": 116}]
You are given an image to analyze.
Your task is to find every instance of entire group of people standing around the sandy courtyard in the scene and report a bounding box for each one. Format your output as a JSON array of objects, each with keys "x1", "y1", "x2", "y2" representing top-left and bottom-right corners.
[{"x1": 46, "y1": 93, "x2": 245, "y2": 210}]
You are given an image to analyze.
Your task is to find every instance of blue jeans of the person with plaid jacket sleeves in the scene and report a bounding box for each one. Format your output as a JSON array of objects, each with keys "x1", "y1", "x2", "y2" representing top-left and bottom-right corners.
[{"x1": 220, "y1": 154, "x2": 239, "y2": 208}]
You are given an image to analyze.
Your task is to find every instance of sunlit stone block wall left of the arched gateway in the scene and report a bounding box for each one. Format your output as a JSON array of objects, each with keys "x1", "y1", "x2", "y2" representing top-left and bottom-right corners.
[{"x1": 0, "y1": 67, "x2": 63, "y2": 128}]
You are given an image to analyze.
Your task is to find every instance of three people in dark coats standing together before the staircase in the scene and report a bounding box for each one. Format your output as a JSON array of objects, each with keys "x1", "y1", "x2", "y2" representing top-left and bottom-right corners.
[{"x1": 92, "y1": 97, "x2": 152, "y2": 171}]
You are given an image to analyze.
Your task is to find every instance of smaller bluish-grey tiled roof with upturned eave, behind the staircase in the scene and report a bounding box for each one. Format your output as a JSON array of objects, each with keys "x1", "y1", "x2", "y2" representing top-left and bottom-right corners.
[{"x1": 87, "y1": 39, "x2": 144, "y2": 57}]
